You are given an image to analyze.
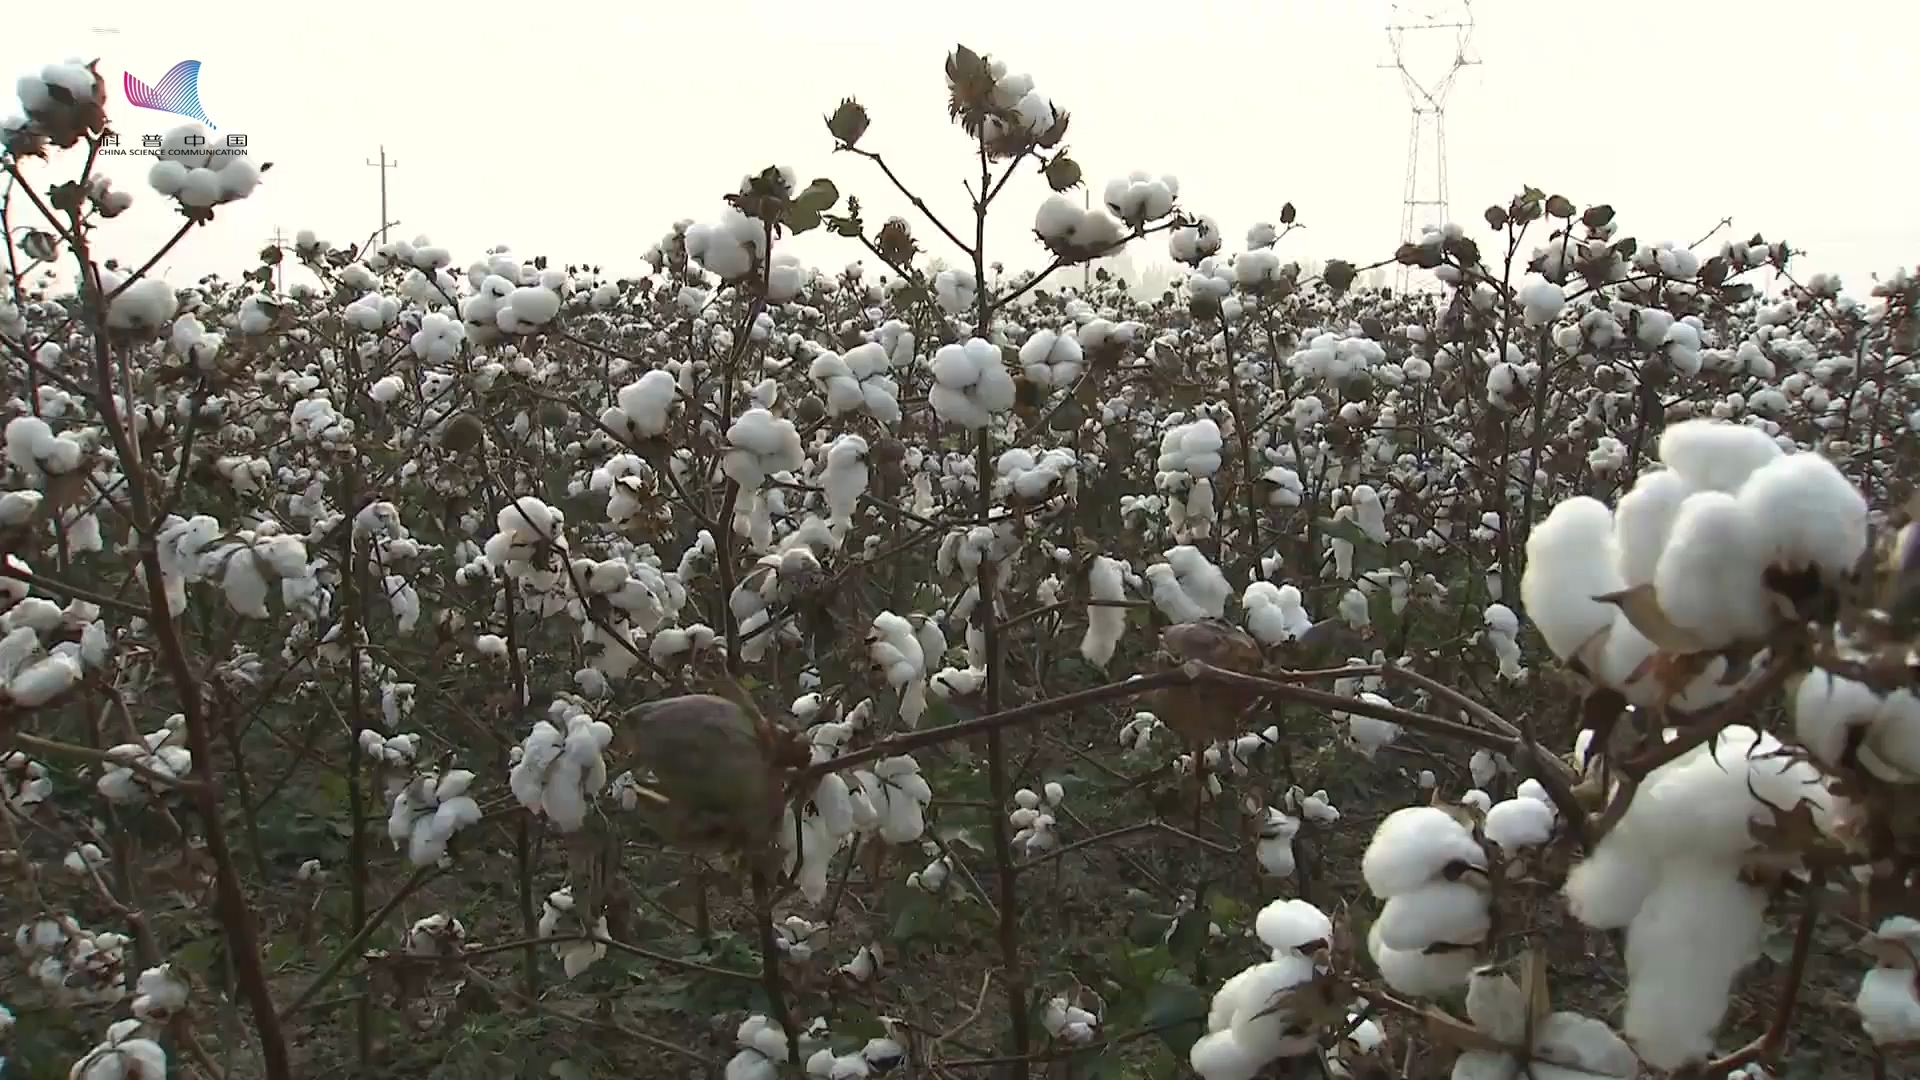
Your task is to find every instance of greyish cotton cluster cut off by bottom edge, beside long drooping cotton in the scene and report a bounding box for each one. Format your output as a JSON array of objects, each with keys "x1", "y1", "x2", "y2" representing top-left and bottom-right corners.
[{"x1": 1453, "y1": 967, "x2": 1640, "y2": 1080}]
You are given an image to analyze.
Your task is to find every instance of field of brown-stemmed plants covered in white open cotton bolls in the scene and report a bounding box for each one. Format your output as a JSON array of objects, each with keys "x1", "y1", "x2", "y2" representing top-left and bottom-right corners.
[{"x1": 0, "y1": 48, "x2": 1920, "y2": 1080}]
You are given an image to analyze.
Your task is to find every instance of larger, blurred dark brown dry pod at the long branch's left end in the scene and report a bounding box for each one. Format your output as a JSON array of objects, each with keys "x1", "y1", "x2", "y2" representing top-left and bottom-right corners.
[{"x1": 614, "y1": 694, "x2": 780, "y2": 851}]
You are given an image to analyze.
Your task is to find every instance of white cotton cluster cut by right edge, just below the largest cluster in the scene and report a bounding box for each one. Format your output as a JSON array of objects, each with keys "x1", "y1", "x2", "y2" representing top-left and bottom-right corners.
[{"x1": 1791, "y1": 667, "x2": 1920, "y2": 784}]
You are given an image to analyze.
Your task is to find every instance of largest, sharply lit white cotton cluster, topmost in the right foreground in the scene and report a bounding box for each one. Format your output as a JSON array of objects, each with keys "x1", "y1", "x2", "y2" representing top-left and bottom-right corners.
[{"x1": 1521, "y1": 419, "x2": 1866, "y2": 691}]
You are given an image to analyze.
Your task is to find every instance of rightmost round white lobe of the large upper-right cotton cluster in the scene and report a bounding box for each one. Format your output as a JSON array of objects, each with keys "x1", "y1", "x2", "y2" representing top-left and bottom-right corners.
[{"x1": 1738, "y1": 454, "x2": 1866, "y2": 580}]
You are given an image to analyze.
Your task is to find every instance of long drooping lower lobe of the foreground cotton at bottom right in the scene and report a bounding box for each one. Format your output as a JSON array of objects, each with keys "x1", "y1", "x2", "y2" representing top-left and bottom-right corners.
[{"x1": 1620, "y1": 859, "x2": 1766, "y2": 1070}]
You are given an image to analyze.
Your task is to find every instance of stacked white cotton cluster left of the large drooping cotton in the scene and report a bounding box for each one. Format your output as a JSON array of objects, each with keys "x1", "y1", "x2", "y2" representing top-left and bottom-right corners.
[{"x1": 1359, "y1": 807, "x2": 1492, "y2": 997}]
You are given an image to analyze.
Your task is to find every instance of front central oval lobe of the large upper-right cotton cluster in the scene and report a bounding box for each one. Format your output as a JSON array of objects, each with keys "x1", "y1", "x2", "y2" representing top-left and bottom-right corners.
[{"x1": 1653, "y1": 490, "x2": 1774, "y2": 650}]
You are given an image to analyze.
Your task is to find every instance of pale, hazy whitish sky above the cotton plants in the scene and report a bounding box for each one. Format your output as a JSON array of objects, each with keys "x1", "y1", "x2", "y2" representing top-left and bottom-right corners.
[{"x1": 0, "y1": 0, "x2": 1920, "y2": 292}]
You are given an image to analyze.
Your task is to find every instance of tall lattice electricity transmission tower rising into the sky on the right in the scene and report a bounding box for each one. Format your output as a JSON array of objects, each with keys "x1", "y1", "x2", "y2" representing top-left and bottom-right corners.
[{"x1": 1380, "y1": 0, "x2": 1480, "y2": 292}]
